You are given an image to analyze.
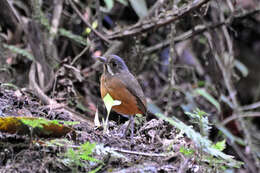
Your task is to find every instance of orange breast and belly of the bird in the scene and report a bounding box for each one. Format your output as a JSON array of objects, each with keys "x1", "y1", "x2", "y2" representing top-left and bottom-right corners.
[{"x1": 100, "y1": 74, "x2": 146, "y2": 115}]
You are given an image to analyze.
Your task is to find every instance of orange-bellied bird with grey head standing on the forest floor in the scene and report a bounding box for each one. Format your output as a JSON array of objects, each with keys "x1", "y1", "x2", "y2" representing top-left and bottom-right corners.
[{"x1": 97, "y1": 55, "x2": 147, "y2": 141}]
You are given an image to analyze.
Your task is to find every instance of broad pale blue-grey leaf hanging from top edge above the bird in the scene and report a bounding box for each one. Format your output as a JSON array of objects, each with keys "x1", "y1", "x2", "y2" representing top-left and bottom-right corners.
[{"x1": 129, "y1": 0, "x2": 148, "y2": 18}]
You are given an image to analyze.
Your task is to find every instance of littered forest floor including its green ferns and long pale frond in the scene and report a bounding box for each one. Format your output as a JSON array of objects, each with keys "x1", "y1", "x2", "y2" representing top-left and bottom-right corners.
[{"x1": 0, "y1": 89, "x2": 242, "y2": 172}]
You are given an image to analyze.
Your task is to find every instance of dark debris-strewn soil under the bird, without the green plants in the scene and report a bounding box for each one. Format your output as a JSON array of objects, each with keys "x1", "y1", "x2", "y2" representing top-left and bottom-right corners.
[{"x1": 0, "y1": 87, "x2": 207, "y2": 173}]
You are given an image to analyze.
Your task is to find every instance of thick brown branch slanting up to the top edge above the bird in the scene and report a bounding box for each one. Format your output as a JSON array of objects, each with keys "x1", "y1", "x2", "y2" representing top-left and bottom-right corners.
[{"x1": 107, "y1": 0, "x2": 210, "y2": 39}]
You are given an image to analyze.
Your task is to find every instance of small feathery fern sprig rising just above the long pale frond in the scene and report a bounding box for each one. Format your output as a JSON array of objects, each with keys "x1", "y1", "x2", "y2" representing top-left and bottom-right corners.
[{"x1": 185, "y1": 109, "x2": 211, "y2": 136}]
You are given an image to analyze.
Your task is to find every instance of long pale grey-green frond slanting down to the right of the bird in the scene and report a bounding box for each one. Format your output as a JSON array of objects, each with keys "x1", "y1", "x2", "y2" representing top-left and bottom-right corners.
[{"x1": 156, "y1": 114, "x2": 243, "y2": 167}]
